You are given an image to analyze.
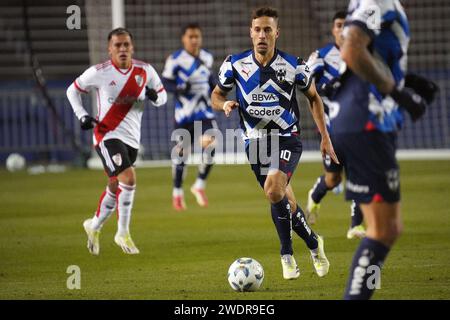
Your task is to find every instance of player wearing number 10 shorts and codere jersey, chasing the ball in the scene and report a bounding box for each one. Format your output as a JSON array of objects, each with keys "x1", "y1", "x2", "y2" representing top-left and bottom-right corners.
[{"x1": 212, "y1": 7, "x2": 338, "y2": 279}]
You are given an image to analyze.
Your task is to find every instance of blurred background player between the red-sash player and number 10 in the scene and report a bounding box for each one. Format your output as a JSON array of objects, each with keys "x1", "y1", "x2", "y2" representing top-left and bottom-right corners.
[{"x1": 162, "y1": 23, "x2": 217, "y2": 211}]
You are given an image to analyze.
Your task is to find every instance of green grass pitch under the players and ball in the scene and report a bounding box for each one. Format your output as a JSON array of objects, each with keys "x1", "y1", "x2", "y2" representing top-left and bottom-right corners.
[{"x1": 0, "y1": 161, "x2": 450, "y2": 300}]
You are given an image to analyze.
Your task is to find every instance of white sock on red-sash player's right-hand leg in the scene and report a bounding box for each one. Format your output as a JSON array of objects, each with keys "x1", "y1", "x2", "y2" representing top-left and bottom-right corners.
[{"x1": 117, "y1": 182, "x2": 136, "y2": 235}]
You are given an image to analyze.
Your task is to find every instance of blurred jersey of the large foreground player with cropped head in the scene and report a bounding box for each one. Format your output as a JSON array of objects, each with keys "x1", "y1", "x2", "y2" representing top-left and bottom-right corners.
[{"x1": 330, "y1": 0, "x2": 409, "y2": 133}]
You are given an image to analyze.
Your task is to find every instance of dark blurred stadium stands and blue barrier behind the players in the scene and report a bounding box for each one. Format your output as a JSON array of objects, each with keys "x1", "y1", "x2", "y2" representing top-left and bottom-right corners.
[{"x1": 0, "y1": 0, "x2": 450, "y2": 162}]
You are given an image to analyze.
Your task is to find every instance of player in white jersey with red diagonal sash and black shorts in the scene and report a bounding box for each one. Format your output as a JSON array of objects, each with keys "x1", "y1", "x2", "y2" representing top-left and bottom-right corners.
[{"x1": 67, "y1": 28, "x2": 167, "y2": 255}]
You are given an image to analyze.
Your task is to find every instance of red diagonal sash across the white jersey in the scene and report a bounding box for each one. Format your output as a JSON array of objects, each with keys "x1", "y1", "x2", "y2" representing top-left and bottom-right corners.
[{"x1": 94, "y1": 66, "x2": 147, "y2": 145}]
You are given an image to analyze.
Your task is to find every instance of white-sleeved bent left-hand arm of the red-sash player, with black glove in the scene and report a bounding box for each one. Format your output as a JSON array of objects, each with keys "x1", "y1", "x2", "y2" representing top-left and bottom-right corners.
[{"x1": 66, "y1": 67, "x2": 98, "y2": 130}]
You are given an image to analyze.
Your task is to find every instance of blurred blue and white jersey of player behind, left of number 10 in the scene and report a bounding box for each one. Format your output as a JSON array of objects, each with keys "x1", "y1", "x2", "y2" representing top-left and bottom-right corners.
[{"x1": 162, "y1": 49, "x2": 214, "y2": 125}]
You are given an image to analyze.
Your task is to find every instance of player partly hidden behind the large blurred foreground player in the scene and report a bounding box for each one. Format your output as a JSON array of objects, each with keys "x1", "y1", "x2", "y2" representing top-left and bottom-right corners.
[{"x1": 305, "y1": 11, "x2": 365, "y2": 239}]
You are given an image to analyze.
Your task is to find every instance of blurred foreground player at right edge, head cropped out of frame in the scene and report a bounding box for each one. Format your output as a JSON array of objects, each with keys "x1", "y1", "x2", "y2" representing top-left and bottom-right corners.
[{"x1": 338, "y1": 0, "x2": 427, "y2": 299}]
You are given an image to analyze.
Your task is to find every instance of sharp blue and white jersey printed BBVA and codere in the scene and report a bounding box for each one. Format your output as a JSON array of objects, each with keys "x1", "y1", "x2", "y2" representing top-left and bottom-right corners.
[{"x1": 218, "y1": 50, "x2": 311, "y2": 140}]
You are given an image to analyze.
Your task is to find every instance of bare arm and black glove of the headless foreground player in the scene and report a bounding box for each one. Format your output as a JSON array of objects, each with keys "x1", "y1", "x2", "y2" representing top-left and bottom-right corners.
[{"x1": 341, "y1": 24, "x2": 427, "y2": 121}]
